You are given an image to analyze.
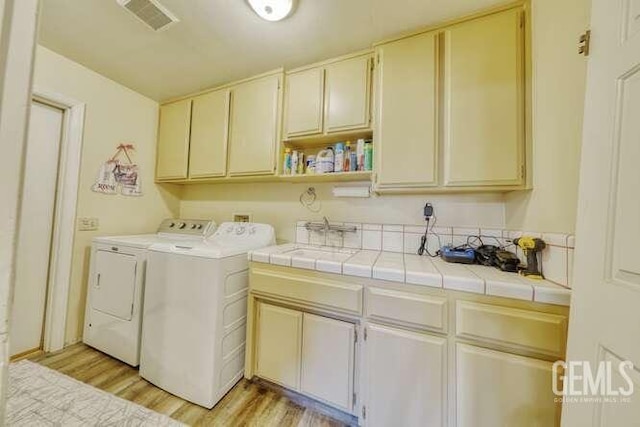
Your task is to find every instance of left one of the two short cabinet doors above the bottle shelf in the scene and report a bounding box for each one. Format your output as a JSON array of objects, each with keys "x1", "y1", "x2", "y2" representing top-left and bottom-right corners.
[{"x1": 285, "y1": 68, "x2": 324, "y2": 138}]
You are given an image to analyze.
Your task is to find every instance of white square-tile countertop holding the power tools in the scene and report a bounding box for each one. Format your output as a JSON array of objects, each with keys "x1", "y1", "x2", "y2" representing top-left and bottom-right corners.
[{"x1": 249, "y1": 243, "x2": 571, "y2": 306}]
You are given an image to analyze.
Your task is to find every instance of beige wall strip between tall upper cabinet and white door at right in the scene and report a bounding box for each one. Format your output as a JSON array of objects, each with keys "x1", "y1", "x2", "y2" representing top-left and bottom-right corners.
[{"x1": 505, "y1": 0, "x2": 591, "y2": 233}]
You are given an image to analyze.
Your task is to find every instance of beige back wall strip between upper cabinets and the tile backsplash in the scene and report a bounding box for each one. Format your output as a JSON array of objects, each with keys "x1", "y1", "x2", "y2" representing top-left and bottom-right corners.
[{"x1": 180, "y1": 183, "x2": 504, "y2": 241}]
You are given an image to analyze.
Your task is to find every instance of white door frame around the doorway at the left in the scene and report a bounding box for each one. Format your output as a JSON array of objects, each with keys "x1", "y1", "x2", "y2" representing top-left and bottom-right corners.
[{"x1": 32, "y1": 85, "x2": 85, "y2": 352}]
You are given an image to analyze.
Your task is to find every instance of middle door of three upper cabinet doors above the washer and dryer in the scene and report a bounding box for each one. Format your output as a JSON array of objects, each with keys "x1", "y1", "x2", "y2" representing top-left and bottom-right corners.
[{"x1": 189, "y1": 90, "x2": 229, "y2": 178}]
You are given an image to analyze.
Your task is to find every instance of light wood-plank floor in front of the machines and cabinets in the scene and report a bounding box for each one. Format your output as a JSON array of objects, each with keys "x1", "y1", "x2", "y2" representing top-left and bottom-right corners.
[{"x1": 27, "y1": 344, "x2": 346, "y2": 427}]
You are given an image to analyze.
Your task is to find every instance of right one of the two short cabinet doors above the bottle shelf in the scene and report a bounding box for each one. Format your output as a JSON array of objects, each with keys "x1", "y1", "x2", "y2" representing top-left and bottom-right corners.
[{"x1": 325, "y1": 55, "x2": 371, "y2": 132}]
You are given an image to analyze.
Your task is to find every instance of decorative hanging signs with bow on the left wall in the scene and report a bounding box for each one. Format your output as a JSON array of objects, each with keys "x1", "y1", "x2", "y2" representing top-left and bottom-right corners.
[{"x1": 91, "y1": 144, "x2": 142, "y2": 196}]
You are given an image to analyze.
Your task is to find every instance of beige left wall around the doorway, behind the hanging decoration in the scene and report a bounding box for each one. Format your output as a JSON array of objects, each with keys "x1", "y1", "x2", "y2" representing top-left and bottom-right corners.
[{"x1": 34, "y1": 47, "x2": 179, "y2": 343}]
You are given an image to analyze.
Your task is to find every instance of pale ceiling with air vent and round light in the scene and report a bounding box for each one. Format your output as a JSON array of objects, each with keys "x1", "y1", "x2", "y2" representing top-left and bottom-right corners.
[{"x1": 40, "y1": 0, "x2": 505, "y2": 100}]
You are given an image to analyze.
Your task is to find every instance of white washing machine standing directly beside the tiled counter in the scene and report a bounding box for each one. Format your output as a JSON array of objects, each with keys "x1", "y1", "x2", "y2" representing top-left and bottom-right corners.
[{"x1": 140, "y1": 223, "x2": 275, "y2": 408}]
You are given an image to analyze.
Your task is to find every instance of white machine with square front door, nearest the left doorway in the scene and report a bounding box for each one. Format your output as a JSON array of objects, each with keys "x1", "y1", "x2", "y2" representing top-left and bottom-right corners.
[{"x1": 82, "y1": 219, "x2": 215, "y2": 366}]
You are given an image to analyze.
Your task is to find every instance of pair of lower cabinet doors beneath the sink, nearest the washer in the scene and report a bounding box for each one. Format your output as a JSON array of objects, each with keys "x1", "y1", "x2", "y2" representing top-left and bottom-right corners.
[{"x1": 256, "y1": 302, "x2": 356, "y2": 412}]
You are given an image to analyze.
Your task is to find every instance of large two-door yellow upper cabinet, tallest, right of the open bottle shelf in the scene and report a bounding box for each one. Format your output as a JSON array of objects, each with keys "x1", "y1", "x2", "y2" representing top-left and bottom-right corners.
[{"x1": 374, "y1": 7, "x2": 525, "y2": 191}]
